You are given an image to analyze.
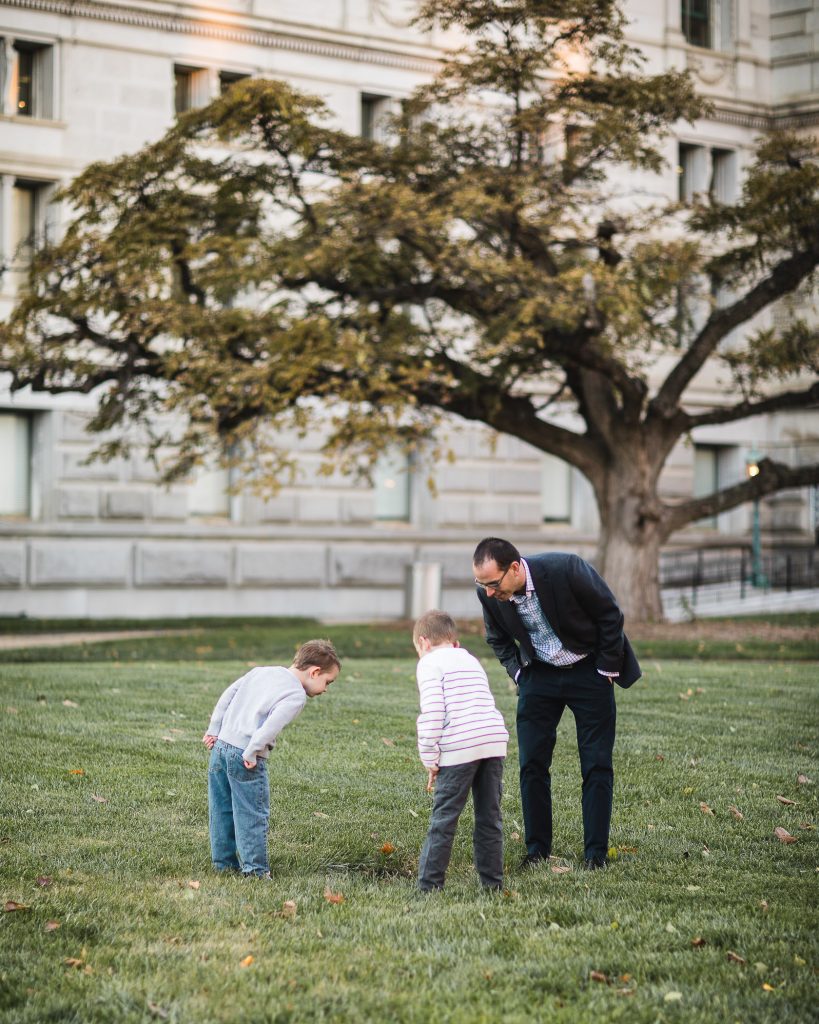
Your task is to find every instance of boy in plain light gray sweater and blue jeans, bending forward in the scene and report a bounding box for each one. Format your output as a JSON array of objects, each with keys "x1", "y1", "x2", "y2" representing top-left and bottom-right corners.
[{"x1": 202, "y1": 640, "x2": 341, "y2": 879}]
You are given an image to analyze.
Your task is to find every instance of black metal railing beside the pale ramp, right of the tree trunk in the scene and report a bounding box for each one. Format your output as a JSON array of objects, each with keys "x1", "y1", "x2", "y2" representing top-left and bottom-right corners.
[{"x1": 659, "y1": 545, "x2": 819, "y2": 597}]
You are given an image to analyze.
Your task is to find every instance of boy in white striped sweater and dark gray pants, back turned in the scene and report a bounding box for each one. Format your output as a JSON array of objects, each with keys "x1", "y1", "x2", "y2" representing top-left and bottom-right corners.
[{"x1": 413, "y1": 610, "x2": 509, "y2": 892}]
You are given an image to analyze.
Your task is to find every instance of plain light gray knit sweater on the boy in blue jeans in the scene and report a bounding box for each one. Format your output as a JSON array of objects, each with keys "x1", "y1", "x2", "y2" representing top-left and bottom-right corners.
[{"x1": 208, "y1": 666, "x2": 307, "y2": 764}]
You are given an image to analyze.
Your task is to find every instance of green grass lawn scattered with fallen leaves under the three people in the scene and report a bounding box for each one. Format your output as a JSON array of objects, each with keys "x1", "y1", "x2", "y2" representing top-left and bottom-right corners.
[{"x1": 0, "y1": 651, "x2": 819, "y2": 1024}]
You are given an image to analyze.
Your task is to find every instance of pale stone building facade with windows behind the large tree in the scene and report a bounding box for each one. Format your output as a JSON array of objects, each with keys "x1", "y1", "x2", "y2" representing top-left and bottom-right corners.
[{"x1": 0, "y1": 0, "x2": 819, "y2": 618}]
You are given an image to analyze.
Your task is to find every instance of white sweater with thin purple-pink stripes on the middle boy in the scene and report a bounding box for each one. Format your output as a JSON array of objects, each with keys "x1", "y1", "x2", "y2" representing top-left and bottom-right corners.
[{"x1": 416, "y1": 646, "x2": 509, "y2": 768}]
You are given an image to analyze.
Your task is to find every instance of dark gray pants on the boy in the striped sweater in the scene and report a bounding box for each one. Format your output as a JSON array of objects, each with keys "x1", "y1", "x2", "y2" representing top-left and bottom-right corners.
[{"x1": 418, "y1": 758, "x2": 504, "y2": 892}]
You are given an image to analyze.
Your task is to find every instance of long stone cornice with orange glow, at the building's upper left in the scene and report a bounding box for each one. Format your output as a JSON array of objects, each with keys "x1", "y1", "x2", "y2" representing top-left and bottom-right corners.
[{"x1": 1, "y1": 0, "x2": 438, "y2": 74}]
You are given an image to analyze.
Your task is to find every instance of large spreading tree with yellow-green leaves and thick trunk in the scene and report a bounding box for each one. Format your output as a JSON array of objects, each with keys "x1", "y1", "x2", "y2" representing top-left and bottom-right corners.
[{"x1": 3, "y1": 0, "x2": 819, "y2": 618}]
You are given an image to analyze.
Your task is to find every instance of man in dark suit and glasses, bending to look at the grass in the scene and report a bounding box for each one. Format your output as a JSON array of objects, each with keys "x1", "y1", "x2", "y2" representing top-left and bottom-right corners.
[{"x1": 472, "y1": 537, "x2": 640, "y2": 870}]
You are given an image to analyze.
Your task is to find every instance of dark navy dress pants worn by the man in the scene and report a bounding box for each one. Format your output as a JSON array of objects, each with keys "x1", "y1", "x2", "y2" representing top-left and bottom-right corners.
[{"x1": 517, "y1": 657, "x2": 616, "y2": 860}]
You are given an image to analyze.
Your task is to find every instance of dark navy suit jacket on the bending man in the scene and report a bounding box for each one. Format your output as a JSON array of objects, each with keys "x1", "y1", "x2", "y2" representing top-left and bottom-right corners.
[{"x1": 477, "y1": 552, "x2": 642, "y2": 686}]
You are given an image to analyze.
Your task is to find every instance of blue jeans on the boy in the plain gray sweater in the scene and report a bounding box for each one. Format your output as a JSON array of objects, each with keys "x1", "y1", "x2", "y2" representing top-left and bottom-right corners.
[{"x1": 208, "y1": 739, "x2": 270, "y2": 874}]
